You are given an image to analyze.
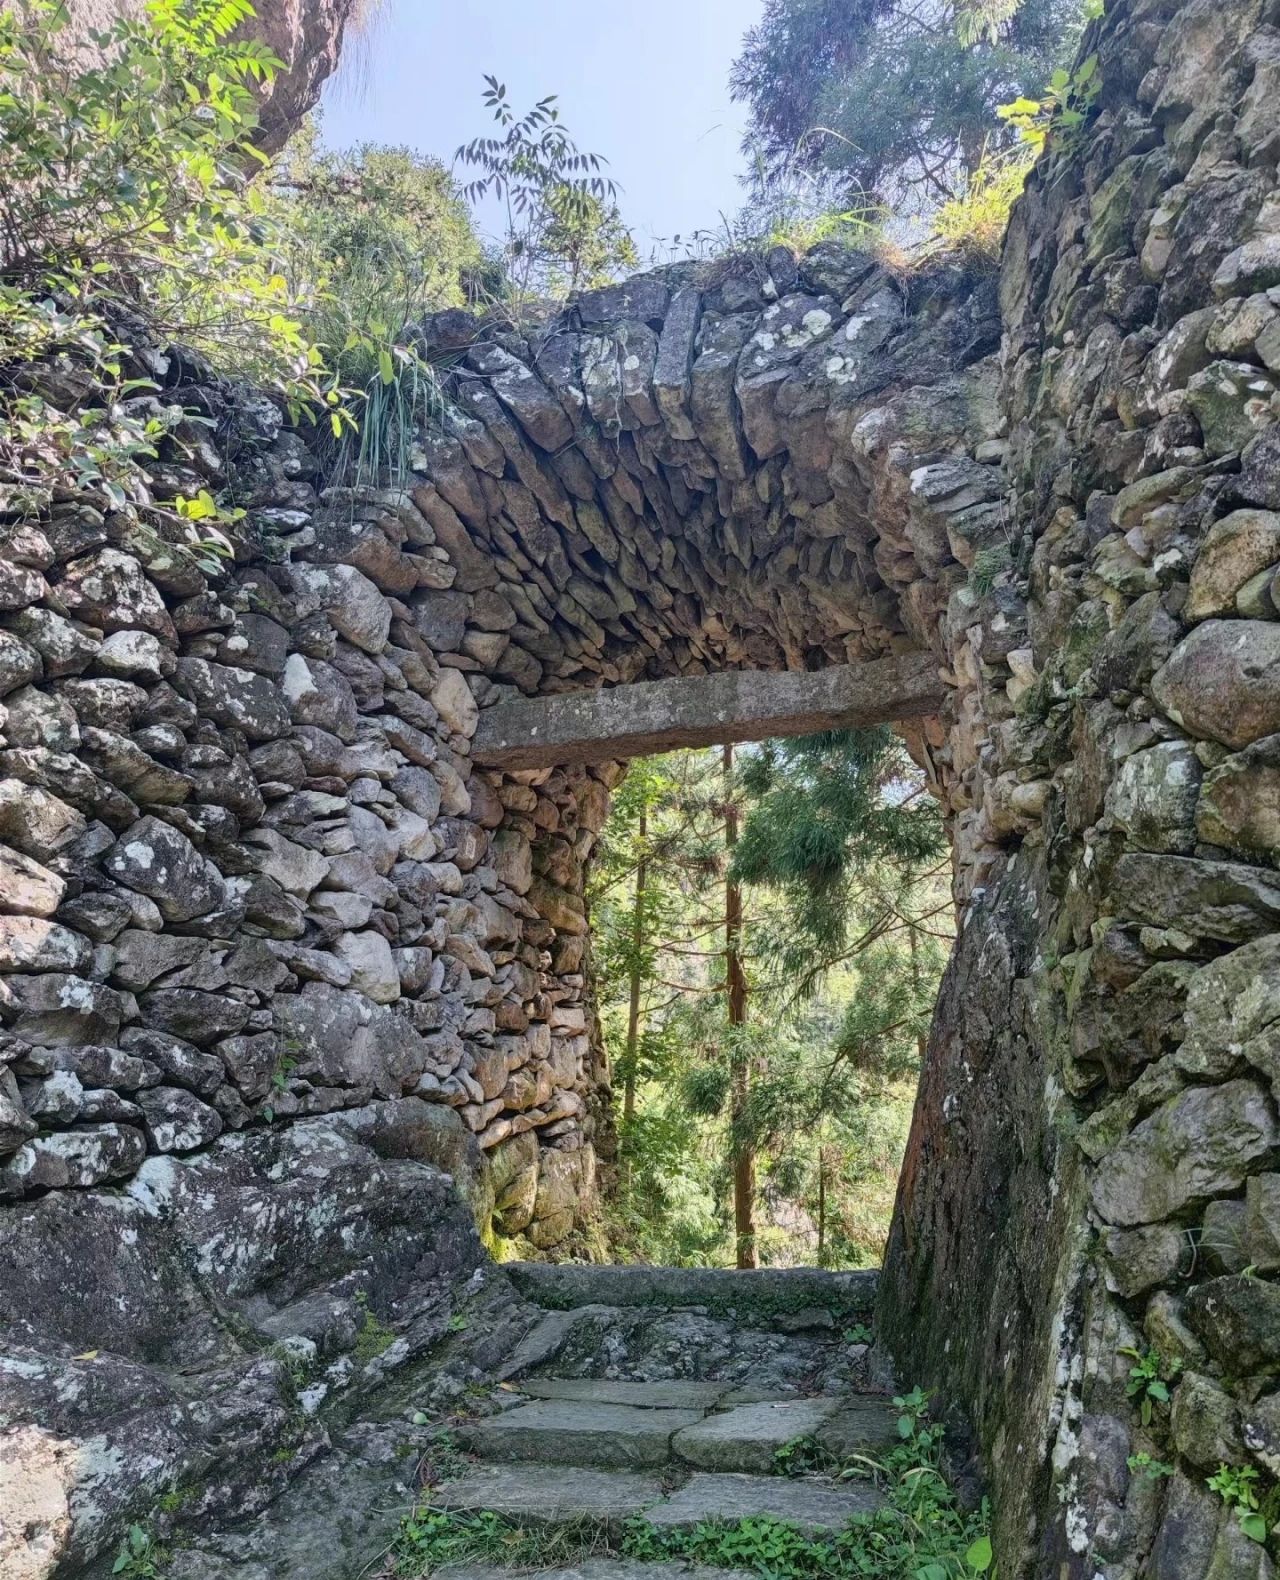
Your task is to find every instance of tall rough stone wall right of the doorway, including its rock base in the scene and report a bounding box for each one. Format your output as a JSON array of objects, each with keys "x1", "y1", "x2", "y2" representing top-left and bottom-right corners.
[{"x1": 885, "y1": 0, "x2": 1280, "y2": 1580}]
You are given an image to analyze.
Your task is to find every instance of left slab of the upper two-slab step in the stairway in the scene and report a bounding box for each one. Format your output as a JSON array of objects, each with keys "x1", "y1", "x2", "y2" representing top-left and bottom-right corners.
[{"x1": 458, "y1": 1398, "x2": 702, "y2": 1469}]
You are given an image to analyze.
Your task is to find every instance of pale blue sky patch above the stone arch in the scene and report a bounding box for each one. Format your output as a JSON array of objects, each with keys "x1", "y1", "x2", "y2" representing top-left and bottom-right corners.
[{"x1": 321, "y1": 0, "x2": 762, "y2": 258}]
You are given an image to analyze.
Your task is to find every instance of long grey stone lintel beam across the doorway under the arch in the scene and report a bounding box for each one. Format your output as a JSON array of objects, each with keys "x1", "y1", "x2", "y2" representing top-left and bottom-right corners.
[{"x1": 471, "y1": 653, "x2": 947, "y2": 768}]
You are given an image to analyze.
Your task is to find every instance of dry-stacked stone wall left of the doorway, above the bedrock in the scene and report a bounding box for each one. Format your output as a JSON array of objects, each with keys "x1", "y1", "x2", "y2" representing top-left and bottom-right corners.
[{"x1": 0, "y1": 354, "x2": 610, "y2": 1245}]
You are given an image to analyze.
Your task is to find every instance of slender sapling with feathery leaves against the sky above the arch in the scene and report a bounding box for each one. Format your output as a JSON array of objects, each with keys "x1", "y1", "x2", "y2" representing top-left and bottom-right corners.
[{"x1": 454, "y1": 76, "x2": 638, "y2": 303}]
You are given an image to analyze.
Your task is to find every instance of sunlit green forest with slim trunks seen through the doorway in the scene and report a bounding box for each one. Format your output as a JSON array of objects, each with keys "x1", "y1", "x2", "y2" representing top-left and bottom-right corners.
[{"x1": 588, "y1": 728, "x2": 953, "y2": 1267}]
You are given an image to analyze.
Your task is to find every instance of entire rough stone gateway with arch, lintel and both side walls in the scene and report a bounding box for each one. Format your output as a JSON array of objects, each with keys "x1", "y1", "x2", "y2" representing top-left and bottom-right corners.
[{"x1": 0, "y1": 0, "x2": 1280, "y2": 1580}]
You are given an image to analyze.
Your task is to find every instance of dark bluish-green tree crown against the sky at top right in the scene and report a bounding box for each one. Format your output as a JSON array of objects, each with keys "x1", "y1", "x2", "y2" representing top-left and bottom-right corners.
[{"x1": 730, "y1": 0, "x2": 1082, "y2": 213}]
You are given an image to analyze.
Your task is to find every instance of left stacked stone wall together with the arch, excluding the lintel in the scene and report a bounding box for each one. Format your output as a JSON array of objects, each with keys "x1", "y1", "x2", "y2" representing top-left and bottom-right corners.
[{"x1": 0, "y1": 237, "x2": 1002, "y2": 1248}]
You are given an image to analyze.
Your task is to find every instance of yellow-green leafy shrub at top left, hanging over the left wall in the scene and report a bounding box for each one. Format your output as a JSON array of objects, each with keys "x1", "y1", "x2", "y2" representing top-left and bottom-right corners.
[{"x1": 0, "y1": 0, "x2": 344, "y2": 530}]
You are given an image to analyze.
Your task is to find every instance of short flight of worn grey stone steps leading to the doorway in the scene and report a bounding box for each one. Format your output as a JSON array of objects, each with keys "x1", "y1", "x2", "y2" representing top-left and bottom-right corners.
[{"x1": 431, "y1": 1264, "x2": 896, "y2": 1580}]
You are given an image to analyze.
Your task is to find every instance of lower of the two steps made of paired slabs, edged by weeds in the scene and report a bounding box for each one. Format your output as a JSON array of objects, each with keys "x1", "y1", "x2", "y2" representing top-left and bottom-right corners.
[{"x1": 431, "y1": 1463, "x2": 882, "y2": 1539}]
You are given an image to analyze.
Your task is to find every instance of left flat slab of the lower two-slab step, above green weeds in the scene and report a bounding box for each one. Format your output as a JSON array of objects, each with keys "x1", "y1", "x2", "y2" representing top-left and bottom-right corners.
[{"x1": 431, "y1": 1465, "x2": 662, "y2": 1526}]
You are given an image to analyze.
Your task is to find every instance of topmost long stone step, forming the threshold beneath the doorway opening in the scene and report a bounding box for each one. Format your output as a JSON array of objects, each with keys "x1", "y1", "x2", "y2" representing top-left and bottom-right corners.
[{"x1": 504, "y1": 1262, "x2": 880, "y2": 1330}]
